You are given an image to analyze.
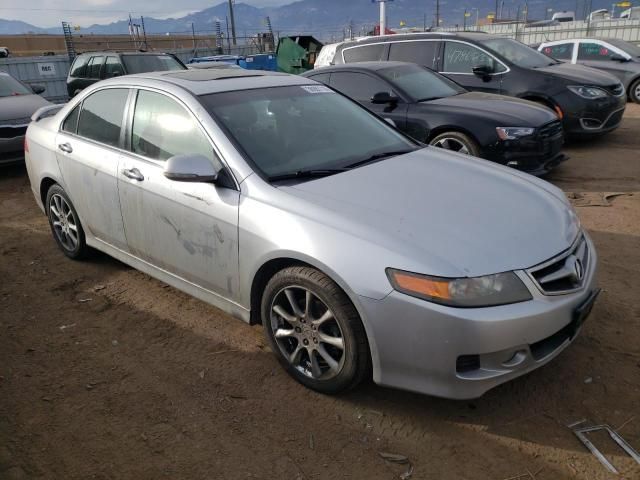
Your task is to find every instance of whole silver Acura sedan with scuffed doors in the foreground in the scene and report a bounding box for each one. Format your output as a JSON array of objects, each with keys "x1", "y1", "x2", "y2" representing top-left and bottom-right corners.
[{"x1": 25, "y1": 70, "x2": 598, "y2": 398}]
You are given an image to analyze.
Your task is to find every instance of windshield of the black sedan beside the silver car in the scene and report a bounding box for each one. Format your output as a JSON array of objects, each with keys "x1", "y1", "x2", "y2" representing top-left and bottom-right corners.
[{"x1": 378, "y1": 65, "x2": 466, "y2": 102}]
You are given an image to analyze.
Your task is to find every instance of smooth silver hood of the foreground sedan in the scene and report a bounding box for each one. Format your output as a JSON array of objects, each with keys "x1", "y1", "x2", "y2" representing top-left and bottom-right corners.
[{"x1": 280, "y1": 147, "x2": 580, "y2": 277}]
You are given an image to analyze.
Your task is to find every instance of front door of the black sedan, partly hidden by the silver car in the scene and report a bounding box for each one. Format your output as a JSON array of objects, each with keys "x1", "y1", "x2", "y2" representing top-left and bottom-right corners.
[{"x1": 330, "y1": 71, "x2": 407, "y2": 129}]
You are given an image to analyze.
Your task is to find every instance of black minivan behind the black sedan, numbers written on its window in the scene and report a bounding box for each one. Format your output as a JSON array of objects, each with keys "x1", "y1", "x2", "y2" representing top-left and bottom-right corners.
[{"x1": 316, "y1": 33, "x2": 626, "y2": 134}]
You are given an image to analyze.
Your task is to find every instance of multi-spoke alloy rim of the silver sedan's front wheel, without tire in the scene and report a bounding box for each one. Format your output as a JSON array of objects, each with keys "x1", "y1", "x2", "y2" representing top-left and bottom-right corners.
[{"x1": 270, "y1": 286, "x2": 345, "y2": 380}]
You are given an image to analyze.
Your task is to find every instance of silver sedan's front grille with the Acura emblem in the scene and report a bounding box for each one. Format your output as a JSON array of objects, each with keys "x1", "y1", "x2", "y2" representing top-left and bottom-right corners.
[{"x1": 527, "y1": 235, "x2": 589, "y2": 295}]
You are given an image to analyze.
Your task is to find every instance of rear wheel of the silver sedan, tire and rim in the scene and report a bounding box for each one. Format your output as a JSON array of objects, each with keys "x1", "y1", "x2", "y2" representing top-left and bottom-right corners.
[{"x1": 45, "y1": 184, "x2": 89, "y2": 260}]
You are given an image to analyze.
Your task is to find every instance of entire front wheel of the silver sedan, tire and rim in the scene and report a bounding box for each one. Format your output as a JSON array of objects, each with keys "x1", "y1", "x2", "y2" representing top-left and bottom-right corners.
[{"x1": 260, "y1": 266, "x2": 370, "y2": 394}]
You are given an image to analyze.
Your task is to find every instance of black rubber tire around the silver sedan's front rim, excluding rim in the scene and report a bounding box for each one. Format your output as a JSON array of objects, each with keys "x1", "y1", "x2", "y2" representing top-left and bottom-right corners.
[{"x1": 260, "y1": 267, "x2": 364, "y2": 394}]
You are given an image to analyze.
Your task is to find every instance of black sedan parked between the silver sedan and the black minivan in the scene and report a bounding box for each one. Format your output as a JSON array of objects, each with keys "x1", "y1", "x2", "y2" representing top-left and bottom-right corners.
[{"x1": 304, "y1": 62, "x2": 566, "y2": 175}]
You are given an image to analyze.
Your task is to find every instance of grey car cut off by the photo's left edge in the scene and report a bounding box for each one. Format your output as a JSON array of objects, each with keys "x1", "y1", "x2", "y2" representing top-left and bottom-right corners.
[{"x1": 0, "y1": 72, "x2": 51, "y2": 165}]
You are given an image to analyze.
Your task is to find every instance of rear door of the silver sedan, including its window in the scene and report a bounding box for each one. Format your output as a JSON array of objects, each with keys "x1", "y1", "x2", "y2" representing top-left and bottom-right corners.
[{"x1": 56, "y1": 88, "x2": 129, "y2": 250}]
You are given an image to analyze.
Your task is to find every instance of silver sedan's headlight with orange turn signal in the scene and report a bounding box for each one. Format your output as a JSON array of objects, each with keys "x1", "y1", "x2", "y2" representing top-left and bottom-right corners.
[{"x1": 387, "y1": 268, "x2": 532, "y2": 308}]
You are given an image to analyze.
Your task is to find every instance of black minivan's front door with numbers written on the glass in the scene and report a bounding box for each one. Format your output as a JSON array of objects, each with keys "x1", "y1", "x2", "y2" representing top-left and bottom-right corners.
[{"x1": 439, "y1": 40, "x2": 509, "y2": 93}]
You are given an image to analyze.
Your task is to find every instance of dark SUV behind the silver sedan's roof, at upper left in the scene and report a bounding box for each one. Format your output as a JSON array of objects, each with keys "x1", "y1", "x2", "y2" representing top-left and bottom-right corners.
[{"x1": 67, "y1": 52, "x2": 187, "y2": 97}]
